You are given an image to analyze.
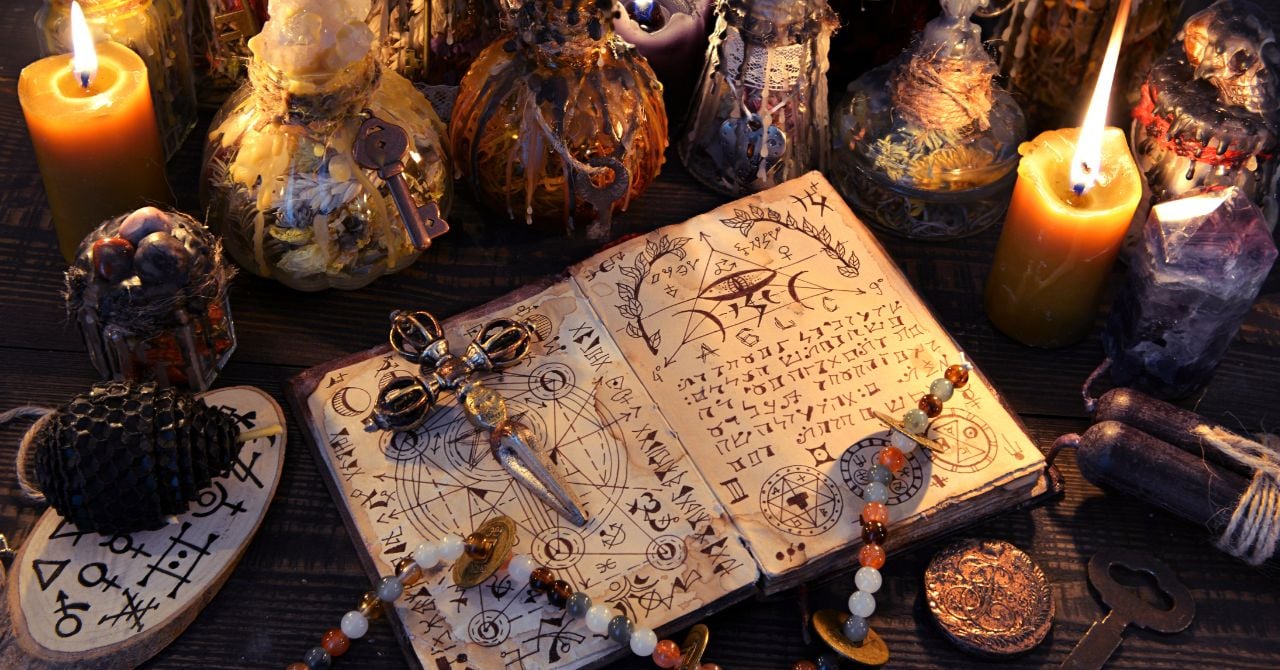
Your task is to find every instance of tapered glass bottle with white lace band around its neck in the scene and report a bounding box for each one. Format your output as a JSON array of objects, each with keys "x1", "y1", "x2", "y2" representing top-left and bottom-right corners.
[{"x1": 680, "y1": 0, "x2": 836, "y2": 196}]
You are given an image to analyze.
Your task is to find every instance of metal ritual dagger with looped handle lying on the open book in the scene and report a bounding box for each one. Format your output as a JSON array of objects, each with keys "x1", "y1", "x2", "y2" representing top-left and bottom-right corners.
[{"x1": 364, "y1": 311, "x2": 586, "y2": 527}]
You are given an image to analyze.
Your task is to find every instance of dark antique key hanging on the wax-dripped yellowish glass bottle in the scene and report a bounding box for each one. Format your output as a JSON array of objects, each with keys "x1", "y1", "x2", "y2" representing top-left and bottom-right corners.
[{"x1": 355, "y1": 111, "x2": 449, "y2": 251}]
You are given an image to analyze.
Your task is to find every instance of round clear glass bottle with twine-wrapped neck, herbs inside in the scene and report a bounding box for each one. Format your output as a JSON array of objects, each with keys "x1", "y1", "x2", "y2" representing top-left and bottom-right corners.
[{"x1": 831, "y1": 0, "x2": 1027, "y2": 241}]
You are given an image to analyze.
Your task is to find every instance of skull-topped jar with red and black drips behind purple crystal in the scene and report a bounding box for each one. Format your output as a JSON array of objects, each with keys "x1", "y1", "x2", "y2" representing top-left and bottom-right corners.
[{"x1": 1130, "y1": 0, "x2": 1280, "y2": 238}]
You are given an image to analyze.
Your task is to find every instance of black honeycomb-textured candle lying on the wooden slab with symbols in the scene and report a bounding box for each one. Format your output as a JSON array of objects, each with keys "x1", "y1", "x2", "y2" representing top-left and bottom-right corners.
[{"x1": 32, "y1": 382, "x2": 239, "y2": 533}]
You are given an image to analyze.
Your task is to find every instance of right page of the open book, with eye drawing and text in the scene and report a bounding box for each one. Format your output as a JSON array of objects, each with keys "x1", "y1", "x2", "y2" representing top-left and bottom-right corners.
[{"x1": 571, "y1": 172, "x2": 1044, "y2": 580}]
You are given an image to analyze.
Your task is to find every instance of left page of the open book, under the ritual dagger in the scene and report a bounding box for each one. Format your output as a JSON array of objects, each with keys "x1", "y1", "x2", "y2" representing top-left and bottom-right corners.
[{"x1": 306, "y1": 281, "x2": 758, "y2": 669}]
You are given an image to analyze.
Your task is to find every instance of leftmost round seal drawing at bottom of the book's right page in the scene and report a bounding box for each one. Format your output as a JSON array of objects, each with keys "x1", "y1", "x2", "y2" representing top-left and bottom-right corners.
[{"x1": 760, "y1": 465, "x2": 845, "y2": 537}]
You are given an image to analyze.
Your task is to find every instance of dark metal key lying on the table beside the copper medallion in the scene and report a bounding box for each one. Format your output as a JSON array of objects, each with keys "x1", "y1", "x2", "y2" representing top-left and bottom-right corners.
[{"x1": 1062, "y1": 550, "x2": 1196, "y2": 670}]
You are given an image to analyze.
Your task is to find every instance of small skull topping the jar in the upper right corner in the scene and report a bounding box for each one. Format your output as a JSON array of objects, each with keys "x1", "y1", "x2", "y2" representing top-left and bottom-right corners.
[{"x1": 1181, "y1": 0, "x2": 1280, "y2": 114}]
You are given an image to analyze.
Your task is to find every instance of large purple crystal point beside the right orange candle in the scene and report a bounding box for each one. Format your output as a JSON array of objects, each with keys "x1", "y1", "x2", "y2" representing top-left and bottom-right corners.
[{"x1": 1102, "y1": 187, "x2": 1276, "y2": 398}]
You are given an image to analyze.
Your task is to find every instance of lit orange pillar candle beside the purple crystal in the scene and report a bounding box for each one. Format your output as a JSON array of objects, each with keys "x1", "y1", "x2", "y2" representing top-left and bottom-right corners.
[{"x1": 987, "y1": 128, "x2": 1142, "y2": 347}]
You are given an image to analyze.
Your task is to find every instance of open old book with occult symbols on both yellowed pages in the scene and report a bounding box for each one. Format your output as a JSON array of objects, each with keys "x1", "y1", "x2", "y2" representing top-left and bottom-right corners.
[{"x1": 291, "y1": 173, "x2": 1053, "y2": 670}]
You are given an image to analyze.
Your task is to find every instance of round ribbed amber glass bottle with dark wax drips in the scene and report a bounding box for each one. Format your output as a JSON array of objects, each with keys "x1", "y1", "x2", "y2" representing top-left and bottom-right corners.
[{"x1": 449, "y1": 0, "x2": 667, "y2": 241}]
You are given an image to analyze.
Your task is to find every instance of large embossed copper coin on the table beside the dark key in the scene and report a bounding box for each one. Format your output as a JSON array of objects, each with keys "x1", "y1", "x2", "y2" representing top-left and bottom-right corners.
[{"x1": 924, "y1": 539, "x2": 1053, "y2": 658}]
